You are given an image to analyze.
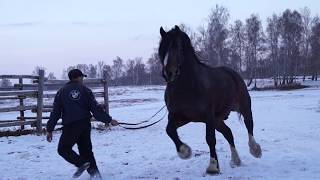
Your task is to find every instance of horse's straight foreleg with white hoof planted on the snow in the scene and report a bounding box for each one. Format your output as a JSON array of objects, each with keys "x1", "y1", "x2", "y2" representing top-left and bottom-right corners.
[{"x1": 206, "y1": 119, "x2": 220, "y2": 174}]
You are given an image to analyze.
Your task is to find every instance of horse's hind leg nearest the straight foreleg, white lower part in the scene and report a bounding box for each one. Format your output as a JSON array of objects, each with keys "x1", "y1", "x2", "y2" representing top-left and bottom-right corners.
[{"x1": 216, "y1": 120, "x2": 241, "y2": 167}]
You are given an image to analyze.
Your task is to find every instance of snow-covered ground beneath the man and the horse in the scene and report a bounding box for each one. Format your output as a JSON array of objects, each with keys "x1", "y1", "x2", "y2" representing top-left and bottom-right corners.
[{"x1": 0, "y1": 86, "x2": 320, "y2": 180}]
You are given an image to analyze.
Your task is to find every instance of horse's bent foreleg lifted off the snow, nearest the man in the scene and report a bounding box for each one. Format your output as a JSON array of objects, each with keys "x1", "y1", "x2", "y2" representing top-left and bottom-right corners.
[{"x1": 166, "y1": 113, "x2": 192, "y2": 159}]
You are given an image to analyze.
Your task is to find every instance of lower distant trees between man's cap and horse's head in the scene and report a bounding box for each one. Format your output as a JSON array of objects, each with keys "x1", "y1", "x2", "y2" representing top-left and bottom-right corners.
[{"x1": 62, "y1": 53, "x2": 164, "y2": 86}]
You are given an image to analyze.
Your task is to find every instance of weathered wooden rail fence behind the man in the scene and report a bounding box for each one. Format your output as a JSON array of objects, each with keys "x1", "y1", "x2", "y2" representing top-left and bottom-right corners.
[{"x1": 0, "y1": 70, "x2": 109, "y2": 134}]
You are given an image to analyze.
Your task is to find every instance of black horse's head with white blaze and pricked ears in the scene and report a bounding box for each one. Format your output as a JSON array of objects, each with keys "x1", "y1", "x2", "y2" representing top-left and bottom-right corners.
[{"x1": 158, "y1": 25, "x2": 190, "y2": 82}]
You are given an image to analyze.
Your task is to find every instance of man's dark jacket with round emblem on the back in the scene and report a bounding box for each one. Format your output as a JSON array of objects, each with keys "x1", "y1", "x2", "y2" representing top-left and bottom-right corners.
[{"x1": 47, "y1": 82, "x2": 112, "y2": 132}]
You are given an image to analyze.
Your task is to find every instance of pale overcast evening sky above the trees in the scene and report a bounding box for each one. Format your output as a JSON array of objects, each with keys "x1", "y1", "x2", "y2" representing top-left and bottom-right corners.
[{"x1": 0, "y1": 0, "x2": 320, "y2": 77}]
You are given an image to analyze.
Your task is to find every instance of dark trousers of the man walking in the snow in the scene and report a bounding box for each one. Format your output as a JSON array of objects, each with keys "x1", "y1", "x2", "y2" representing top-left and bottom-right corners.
[{"x1": 58, "y1": 119, "x2": 99, "y2": 175}]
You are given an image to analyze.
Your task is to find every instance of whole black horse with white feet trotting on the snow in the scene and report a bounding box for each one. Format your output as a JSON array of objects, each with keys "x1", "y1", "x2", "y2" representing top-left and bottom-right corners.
[{"x1": 158, "y1": 26, "x2": 262, "y2": 174}]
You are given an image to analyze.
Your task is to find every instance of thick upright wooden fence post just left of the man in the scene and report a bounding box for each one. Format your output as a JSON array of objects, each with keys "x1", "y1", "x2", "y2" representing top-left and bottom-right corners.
[{"x1": 37, "y1": 69, "x2": 44, "y2": 135}]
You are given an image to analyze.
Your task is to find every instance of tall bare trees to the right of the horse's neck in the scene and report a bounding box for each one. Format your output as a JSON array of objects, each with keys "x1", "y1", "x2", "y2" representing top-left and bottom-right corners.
[{"x1": 190, "y1": 5, "x2": 320, "y2": 87}]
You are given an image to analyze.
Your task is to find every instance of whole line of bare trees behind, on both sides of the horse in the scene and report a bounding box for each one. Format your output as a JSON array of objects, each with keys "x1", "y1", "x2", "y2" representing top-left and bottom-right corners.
[{"x1": 4, "y1": 5, "x2": 320, "y2": 87}]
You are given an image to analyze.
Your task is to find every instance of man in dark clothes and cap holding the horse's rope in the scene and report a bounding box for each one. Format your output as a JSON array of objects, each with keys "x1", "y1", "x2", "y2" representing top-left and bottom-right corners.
[{"x1": 47, "y1": 69, "x2": 118, "y2": 178}]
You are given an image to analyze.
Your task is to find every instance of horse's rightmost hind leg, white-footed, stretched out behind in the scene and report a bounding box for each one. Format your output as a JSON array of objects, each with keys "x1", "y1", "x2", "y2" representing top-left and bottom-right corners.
[{"x1": 240, "y1": 95, "x2": 262, "y2": 158}]
